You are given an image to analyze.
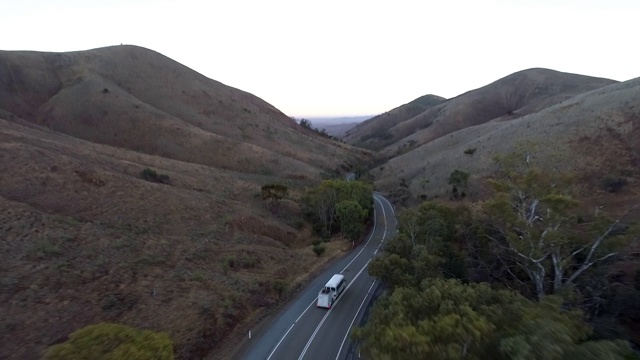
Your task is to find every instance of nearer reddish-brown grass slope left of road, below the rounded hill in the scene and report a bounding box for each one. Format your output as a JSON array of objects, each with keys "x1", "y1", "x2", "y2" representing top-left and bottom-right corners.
[{"x1": 0, "y1": 119, "x2": 356, "y2": 359}]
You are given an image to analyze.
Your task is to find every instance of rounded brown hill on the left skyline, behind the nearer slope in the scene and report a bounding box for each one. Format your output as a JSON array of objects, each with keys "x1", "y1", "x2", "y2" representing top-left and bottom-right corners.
[{"x1": 0, "y1": 46, "x2": 369, "y2": 178}]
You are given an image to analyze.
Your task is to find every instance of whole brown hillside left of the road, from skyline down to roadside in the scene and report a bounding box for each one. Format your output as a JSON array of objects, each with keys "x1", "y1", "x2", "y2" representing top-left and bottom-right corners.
[{"x1": 0, "y1": 46, "x2": 373, "y2": 359}]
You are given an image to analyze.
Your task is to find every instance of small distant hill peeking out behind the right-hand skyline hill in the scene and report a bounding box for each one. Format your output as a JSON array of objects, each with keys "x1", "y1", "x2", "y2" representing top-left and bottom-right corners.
[{"x1": 343, "y1": 95, "x2": 447, "y2": 150}]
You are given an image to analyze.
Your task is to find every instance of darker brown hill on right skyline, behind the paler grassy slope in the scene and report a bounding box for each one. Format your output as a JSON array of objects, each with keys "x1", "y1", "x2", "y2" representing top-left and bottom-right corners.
[{"x1": 348, "y1": 68, "x2": 615, "y2": 156}]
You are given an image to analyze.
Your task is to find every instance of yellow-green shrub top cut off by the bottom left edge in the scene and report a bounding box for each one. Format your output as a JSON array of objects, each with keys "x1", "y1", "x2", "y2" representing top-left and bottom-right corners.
[{"x1": 44, "y1": 323, "x2": 174, "y2": 360}]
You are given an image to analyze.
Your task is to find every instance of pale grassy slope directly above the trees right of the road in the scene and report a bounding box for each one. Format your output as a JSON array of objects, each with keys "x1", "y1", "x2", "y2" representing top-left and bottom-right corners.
[{"x1": 372, "y1": 78, "x2": 640, "y2": 203}]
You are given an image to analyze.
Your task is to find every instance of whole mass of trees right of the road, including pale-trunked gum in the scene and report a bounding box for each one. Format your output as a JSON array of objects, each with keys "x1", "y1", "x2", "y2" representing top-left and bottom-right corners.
[{"x1": 354, "y1": 157, "x2": 640, "y2": 360}]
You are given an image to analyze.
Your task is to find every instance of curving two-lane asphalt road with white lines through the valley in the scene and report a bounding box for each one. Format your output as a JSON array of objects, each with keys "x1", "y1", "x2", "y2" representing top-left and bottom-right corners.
[{"x1": 241, "y1": 193, "x2": 396, "y2": 360}]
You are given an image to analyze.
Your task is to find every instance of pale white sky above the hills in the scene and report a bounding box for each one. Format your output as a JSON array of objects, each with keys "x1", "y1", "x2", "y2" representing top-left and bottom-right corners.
[{"x1": 0, "y1": 0, "x2": 640, "y2": 117}]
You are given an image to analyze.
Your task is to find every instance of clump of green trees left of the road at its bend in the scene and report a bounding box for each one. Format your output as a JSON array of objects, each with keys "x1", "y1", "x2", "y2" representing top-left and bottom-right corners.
[{"x1": 302, "y1": 179, "x2": 373, "y2": 241}]
